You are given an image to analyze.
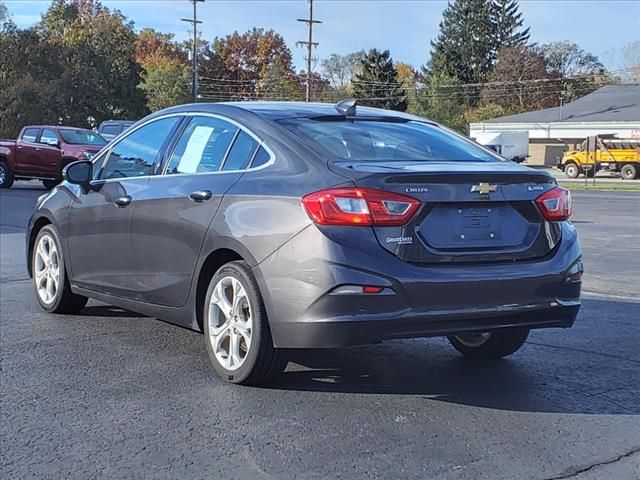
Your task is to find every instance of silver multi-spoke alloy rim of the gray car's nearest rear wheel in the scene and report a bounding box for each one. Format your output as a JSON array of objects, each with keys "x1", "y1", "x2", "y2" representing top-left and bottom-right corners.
[{"x1": 207, "y1": 276, "x2": 253, "y2": 370}]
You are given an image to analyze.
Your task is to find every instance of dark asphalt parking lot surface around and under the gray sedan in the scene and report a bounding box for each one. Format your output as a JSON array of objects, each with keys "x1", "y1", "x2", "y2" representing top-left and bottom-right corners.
[{"x1": 0, "y1": 183, "x2": 640, "y2": 480}]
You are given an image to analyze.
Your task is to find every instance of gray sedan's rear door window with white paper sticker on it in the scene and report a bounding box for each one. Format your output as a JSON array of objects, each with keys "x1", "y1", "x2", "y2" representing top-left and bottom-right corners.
[{"x1": 167, "y1": 117, "x2": 238, "y2": 175}]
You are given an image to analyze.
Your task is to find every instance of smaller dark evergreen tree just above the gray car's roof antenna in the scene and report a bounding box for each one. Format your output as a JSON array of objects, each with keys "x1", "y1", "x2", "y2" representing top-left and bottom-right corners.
[{"x1": 352, "y1": 48, "x2": 407, "y2": 112}]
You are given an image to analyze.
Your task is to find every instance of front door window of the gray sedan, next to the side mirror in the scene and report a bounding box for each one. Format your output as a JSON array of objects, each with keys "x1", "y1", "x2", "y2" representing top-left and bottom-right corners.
[{"x1": 95, "y1": 117, "x2": 180, "y2": 180}]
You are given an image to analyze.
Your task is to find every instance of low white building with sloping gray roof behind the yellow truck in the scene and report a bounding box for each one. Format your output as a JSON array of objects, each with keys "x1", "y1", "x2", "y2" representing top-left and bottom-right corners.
[{"x1": 469, "y1": 85, "x2": 640, "y2": 165}]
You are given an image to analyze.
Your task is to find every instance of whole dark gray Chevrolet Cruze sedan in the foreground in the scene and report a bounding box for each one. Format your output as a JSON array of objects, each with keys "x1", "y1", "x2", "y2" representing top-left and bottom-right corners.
[{"x1": 27, "y1": 102, "x2": 582, "y2": 384}]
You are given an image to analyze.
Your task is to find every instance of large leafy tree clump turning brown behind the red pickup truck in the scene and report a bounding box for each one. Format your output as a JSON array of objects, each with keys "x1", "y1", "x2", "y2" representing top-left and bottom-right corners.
[{"x1": 0, "y1": 0, "x2": 147, "y2": 136}]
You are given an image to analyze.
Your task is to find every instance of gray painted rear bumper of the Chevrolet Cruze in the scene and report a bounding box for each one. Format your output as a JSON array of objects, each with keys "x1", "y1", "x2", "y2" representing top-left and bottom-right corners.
[{"x1": 254, "y1": 222, "x2": 581, "y2": 348}]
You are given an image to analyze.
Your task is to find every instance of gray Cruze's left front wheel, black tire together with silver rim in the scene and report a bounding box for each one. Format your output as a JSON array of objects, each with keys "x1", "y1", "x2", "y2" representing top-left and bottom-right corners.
[{"x1": 30, "y1": 225, "x2": 89, "y2": 313}]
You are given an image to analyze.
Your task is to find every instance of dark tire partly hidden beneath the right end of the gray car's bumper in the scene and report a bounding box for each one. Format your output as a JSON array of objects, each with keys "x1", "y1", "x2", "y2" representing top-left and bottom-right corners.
[{"x1": 447, "y1": 328, "x2": 529, "y2": 360}]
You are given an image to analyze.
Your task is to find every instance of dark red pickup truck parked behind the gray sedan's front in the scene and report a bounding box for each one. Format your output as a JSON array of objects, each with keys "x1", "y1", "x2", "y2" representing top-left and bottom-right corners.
[{"x1": 0, "y1": 125, "x2": 107, "y2": 189}]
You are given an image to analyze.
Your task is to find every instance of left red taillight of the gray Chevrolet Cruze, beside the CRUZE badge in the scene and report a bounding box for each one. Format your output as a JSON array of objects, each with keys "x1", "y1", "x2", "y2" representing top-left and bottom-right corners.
[{"x1": 302, "y1": 188, "x2": 420, "y2": 227}]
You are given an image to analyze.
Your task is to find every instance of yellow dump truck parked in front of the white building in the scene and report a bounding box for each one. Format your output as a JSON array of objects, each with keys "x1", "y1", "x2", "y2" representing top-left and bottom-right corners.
[{"x1": 558, "y1": 137, "x2": 640, "y2": 180}]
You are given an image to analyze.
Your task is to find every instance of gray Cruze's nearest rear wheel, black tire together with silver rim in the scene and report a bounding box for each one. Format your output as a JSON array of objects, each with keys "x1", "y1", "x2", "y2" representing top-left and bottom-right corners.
[{"x1": 203, "y1": 261, "x2": 287, "y2": 385}]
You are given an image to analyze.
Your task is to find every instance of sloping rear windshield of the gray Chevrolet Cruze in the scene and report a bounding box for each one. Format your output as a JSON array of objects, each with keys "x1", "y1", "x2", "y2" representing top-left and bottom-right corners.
[{"x1": 280, "y1": 118, "x2": 499, "y2": 162}]
